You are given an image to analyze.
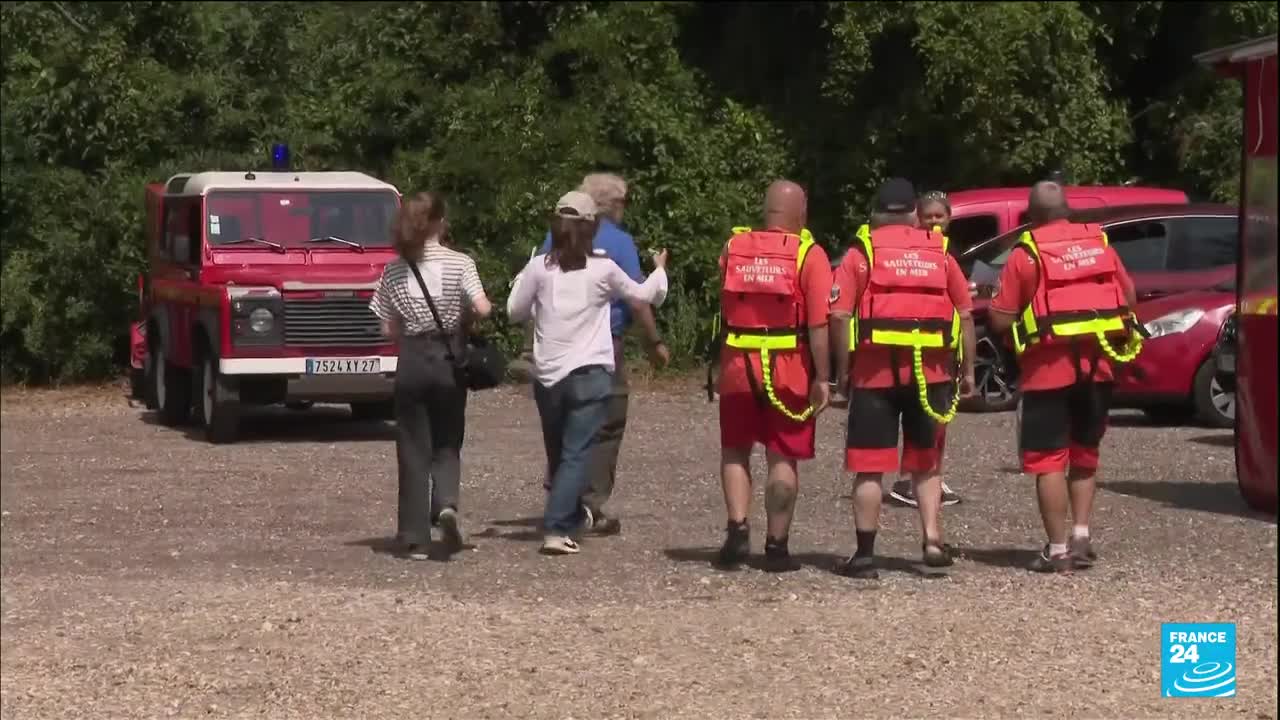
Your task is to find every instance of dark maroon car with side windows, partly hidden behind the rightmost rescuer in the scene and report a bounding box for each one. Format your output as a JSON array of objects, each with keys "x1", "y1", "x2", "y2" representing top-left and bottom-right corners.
[{"x1": 960, "y1": 204, "x2": 1240, "y2": 411}]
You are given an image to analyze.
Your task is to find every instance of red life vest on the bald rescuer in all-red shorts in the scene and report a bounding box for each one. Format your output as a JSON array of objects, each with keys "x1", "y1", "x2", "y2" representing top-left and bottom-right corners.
[{"x1": 721, "y1": 229, "x2": 813, "y2": 334}]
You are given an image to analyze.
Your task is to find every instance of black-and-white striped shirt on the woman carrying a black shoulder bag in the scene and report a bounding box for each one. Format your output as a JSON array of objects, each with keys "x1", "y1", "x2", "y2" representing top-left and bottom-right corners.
[{"x1": 369, "y1": 242, "x2": 485, "y2": 334}]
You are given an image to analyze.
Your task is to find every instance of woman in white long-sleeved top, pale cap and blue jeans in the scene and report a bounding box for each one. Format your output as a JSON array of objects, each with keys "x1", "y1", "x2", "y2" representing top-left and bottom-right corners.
[{"x1": 507, "y1": 192, "x2": 667, "y2": 555}]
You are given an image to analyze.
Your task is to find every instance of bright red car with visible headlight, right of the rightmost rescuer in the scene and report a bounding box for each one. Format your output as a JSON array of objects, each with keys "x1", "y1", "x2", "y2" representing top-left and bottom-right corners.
[{"x1": 1115, "y1": 282, "x2": 1235, "y2": 428}]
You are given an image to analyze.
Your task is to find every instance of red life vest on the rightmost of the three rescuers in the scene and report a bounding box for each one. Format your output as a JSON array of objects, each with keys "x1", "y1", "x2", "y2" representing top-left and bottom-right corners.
[{"x1": 1020, "y1": 223, "x2": 1130, "y2": 342}]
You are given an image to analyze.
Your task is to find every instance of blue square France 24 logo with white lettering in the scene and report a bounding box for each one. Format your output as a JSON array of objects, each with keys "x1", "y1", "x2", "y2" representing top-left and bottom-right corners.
[{"x1": 1160, "y1": 623, "x2": 1235, "y2": 697}]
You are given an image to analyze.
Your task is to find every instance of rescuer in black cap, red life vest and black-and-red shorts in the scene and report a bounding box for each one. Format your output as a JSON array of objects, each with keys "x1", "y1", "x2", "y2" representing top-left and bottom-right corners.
[{"x1": 831, "y1": 178, "x2": 974, "y2": 579}]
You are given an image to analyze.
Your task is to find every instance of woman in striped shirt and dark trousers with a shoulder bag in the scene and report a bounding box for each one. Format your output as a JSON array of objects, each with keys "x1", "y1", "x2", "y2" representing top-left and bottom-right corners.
[{"x1": 370, "y1": 192, "x2": 493, "y2": 560}]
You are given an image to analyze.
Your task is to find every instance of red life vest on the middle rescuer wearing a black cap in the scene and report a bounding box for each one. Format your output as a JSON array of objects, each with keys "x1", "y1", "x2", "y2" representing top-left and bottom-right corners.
[{"x1": 854, "y1": 225, "x2": 959, "y2": 347}]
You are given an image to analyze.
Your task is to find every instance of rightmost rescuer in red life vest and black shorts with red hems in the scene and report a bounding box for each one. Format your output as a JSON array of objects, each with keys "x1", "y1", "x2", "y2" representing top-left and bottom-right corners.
[{"x1": 991, "y1": 182, "x2": 1140, "y2": 573}]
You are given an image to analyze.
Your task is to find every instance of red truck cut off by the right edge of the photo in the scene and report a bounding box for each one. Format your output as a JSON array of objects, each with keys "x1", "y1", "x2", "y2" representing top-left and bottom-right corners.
[{"x1": 1197, "y1": 35, "x2": 1280, "y2": 512}]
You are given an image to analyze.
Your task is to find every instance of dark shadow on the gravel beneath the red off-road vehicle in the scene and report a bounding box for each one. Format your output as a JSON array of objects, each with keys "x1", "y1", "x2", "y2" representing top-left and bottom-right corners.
[{"x1": 142, "y1": 407, "x2": 396, "y2": 445}]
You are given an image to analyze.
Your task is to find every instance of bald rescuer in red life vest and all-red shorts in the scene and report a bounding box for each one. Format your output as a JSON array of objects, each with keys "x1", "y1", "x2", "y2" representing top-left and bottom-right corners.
[{"x1": 718, "y1": 181, "x2": 831, "y2": 570}]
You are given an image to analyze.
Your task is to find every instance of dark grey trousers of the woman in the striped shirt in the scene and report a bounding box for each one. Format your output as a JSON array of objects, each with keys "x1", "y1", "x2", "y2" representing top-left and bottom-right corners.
[{"x1": 396, "y1": 336, "x2": 467, "y2": 544}]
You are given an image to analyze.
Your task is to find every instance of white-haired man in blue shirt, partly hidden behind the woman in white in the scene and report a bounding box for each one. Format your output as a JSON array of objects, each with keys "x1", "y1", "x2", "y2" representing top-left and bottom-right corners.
[{"x1": 541, "y1": 173, "x2": 671, "y2": 536}]
